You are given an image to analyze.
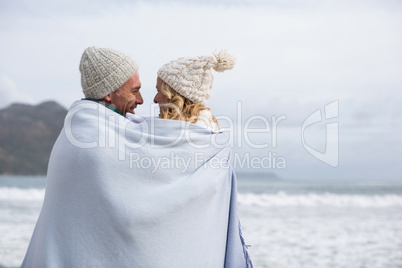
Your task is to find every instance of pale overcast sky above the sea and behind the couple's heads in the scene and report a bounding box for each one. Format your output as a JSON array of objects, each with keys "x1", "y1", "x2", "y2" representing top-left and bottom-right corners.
[{"x1": 0, "y1": 0, "x2": 402, "y2": 180}]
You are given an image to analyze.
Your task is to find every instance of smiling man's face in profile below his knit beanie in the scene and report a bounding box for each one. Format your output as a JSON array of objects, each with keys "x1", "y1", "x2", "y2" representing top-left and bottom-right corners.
[{"x1": 105, "y1": 71, "x2": 144, "y2": 116}]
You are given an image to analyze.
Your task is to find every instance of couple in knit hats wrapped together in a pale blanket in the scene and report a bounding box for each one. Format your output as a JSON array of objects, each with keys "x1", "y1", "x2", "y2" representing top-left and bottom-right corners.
[{"x1": 22, "y1": 47, "x2": 252, "y2": 268}]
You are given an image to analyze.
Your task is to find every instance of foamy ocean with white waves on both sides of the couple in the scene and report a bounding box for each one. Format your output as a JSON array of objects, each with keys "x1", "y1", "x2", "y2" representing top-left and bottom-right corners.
[{"x1": 0, "y1": 174, "x2": 402, "y2": 268}]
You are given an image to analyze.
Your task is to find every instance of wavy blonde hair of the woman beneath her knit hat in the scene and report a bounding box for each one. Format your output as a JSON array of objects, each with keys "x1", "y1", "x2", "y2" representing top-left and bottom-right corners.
[{"x1": 159, "y1": 81, "x2": 219, "y2": 128}]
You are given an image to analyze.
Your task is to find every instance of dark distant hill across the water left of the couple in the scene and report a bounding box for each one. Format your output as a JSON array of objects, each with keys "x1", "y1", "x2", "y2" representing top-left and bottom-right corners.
[{"x1": 0, "y1": 101, "x2": 67, "y2": 175}]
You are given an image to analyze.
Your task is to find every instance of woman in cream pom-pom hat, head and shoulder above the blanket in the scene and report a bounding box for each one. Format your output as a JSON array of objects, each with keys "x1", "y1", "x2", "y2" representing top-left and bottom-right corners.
[{"x1": 154, "y1": 50, "x2": 236, "y2": 133}]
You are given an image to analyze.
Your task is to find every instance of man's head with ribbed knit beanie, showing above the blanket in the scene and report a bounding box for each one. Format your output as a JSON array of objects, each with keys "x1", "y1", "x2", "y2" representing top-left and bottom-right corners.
[{"x1": 80, "y1": 47, "x2": 143, "y2": 116}]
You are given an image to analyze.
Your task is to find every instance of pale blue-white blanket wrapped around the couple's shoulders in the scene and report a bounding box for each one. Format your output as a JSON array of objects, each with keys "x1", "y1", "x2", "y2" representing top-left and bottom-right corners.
[{"x1": 22, "y1": 100, "x2": 252, "y2": 268}]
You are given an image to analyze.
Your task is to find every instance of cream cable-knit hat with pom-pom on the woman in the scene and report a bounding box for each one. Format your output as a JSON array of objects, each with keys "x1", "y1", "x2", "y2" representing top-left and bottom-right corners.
[{"x1": 158, "y1": 50, "x2": 236, "y2": 105}]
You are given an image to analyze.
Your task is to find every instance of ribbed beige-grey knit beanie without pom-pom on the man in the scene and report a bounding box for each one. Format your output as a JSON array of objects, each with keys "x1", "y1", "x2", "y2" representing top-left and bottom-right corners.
[{"x1": 80, "y1": 47, "x2": 138, "y2": 100}]
